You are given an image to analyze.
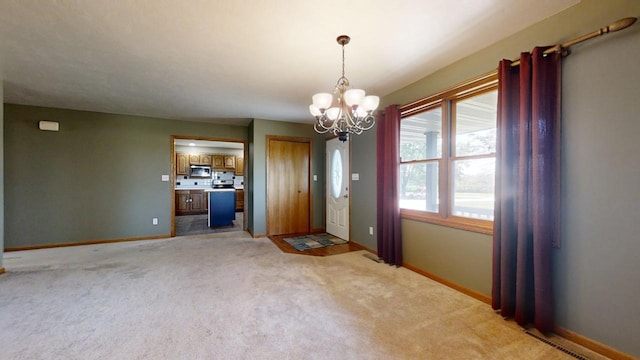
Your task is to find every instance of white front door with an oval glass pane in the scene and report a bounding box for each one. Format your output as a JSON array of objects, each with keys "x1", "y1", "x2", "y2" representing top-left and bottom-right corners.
[{"x1": 325, "y1": 138, "x2": 350, "y2": 240}]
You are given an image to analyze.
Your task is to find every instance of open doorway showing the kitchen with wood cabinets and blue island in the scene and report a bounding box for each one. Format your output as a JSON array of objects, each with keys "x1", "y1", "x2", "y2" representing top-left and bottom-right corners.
[{"x1": 171, "y1": 135, "x2": 247, "y2": 236}]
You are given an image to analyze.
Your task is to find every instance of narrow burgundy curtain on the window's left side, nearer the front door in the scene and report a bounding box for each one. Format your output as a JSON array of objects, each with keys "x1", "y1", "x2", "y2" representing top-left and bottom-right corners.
[{"x1": 377, "y1": 105, "x2": 402, "y2": 266}]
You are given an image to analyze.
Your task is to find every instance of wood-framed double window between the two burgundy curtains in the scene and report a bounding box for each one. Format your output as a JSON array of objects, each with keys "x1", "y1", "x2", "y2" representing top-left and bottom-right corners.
[{"x1": 399, "y1": 75, "x2": 497, "y2": 233}]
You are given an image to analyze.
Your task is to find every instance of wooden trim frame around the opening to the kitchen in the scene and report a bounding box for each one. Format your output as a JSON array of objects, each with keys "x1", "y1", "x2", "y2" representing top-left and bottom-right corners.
[{"x1": 169, "y1": 135, "x2": 251, "y2": 237}]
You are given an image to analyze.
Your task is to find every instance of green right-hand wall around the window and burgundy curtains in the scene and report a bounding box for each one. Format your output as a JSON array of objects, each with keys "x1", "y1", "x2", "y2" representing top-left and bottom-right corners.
[{"x1": 352, "y1": 0, "x2": 640, "y2": 357}]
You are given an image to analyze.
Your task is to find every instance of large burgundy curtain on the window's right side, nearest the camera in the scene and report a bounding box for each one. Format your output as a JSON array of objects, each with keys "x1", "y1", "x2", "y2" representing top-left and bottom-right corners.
[{"x1": 492, "y1": 48, "x2": 562, "y2": 332}]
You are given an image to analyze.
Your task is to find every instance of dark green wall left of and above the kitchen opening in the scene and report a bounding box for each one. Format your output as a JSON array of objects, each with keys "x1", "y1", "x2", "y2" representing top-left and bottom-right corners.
[{"x1": 4, "y1": 104, "x2": 248, "y2": 248}]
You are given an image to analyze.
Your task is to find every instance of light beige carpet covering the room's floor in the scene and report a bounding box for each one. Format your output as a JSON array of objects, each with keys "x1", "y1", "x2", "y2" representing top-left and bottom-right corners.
[{"x1": 0, "y1": 232, "x2": 604, "y2": 359}]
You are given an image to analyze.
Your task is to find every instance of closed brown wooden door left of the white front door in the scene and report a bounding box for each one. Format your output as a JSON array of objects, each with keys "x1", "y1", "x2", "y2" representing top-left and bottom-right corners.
[{"x1": 267, "y1": 137, "x2": 311, "y2": 235}]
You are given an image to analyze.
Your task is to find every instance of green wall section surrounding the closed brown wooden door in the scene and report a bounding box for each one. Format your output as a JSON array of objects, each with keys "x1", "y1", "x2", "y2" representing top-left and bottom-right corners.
[{"x1": 247, "y1": 119, "x2": 325, "y2": 236}]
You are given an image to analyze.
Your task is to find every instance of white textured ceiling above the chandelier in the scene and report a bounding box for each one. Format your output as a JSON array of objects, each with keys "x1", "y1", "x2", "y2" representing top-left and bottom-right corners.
[{"x1": 0, "y1": 0, "x2": 579, "y2": 124}]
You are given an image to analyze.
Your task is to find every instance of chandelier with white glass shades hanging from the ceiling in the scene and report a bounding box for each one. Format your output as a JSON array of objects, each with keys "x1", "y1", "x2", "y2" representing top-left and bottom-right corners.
[{"x1": 309, "y1": 35, "x2": 380, "y2": 142}]
